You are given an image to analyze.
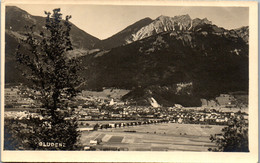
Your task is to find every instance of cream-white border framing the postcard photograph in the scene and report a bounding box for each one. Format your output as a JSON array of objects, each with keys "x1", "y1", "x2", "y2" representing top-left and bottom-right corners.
[{"x1": 1, "y1": 0, "x2": 258, "y2": 163}]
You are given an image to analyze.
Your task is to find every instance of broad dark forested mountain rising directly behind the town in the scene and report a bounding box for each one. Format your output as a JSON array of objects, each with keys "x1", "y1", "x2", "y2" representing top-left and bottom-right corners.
[{"x1": 82, "y1": 19, "x2": 248, "y2": 106}]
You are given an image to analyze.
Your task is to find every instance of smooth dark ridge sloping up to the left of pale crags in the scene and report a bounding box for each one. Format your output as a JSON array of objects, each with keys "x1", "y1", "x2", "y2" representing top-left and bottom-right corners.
[{"x1": 95, "y1": 18, "x2": 152, "y2": 49}]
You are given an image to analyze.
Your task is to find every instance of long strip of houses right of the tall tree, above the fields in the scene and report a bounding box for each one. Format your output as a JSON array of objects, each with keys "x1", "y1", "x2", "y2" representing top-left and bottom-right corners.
[{"x1": 75, "y1": 100, "x2": 248, "y2": 125}]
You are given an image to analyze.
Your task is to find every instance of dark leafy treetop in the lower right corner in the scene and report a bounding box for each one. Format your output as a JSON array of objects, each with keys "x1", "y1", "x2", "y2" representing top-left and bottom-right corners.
[{"x1": 209, "y1": 113, "x2": 249, "y2": 152}]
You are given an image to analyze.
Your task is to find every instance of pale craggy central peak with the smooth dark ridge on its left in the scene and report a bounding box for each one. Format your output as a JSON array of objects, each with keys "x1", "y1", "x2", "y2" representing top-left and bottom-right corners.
[{"x1": 95, "y1": 15, "x2": 211, "y2": 50}]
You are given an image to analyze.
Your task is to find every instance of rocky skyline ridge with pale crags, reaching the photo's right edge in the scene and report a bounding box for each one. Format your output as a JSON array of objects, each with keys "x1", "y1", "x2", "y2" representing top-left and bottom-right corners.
[{"x1": 96, "y1": 14, "x2": 248, "y2": 50}]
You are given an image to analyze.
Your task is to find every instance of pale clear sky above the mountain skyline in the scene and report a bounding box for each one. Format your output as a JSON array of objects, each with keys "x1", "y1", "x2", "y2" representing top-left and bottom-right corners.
[{"x1": 13, "y1": 4, "x2": 249, "y2": 39}]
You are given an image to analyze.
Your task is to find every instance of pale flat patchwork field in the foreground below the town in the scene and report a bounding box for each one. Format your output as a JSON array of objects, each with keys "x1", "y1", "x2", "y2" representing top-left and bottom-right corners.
[{"x1": 81, "y1": 123, "x2": 223, "y2": 151}]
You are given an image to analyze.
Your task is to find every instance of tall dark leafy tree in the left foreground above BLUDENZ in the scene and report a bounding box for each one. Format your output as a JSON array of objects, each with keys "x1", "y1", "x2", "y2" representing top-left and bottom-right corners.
[{"x1": 6, "y1": 8, "x2": 82, "y2": 150}]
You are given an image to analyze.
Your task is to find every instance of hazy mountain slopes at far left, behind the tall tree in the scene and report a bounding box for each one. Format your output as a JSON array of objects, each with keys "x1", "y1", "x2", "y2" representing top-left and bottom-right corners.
[{"x1": 5, "y1": 6, "x2": 100, "y2": 82}]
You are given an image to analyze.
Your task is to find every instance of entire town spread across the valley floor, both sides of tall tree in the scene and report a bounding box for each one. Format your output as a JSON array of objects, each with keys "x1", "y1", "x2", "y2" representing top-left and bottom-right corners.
[{"x1": 5, "y1": 85, "x2": 248, "y2": 127}]
